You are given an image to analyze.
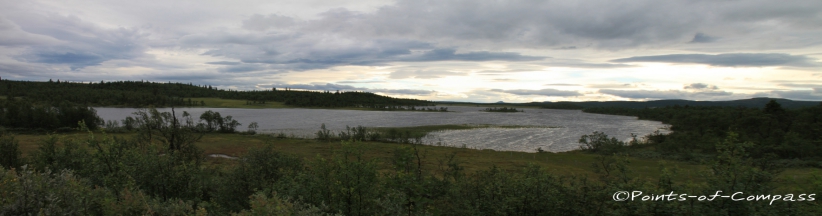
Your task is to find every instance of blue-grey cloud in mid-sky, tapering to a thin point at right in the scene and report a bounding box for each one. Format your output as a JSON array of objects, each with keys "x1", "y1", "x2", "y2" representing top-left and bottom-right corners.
[{"x1": 196, "y1": 33, "x2": 544, "y2": 71}]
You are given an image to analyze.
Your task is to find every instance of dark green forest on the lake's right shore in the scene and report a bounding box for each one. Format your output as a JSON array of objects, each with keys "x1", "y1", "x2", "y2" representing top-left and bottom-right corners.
[{"x1": 583, "y1": 100, "x2": 822, "y2": 167}]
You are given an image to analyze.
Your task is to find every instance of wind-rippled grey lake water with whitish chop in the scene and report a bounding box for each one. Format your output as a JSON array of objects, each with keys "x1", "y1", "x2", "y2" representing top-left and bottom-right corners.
[{"x1": 95, "y1": 106, "x2": 667, "y2": 152}]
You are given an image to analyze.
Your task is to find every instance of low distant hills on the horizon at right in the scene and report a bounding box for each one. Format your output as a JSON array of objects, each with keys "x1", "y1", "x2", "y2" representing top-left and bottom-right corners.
[{"x1": 526, "y1": 98, "x2": 822, "y2": 109}]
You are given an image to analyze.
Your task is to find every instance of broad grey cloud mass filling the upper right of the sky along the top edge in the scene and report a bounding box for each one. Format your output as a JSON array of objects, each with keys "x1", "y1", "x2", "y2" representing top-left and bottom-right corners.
[{"x1": 300, "y1": 0, "x2": 822, "y2": 49}]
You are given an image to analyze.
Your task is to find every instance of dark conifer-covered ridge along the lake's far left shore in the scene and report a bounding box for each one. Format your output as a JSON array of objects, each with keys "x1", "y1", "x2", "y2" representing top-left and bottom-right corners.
[{"x1": 0, "y1": 80, "x2": 433, "y2": 110}]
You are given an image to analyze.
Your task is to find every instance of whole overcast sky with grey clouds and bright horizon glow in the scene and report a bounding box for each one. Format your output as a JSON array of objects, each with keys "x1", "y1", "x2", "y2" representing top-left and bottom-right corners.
[{"x1": 0, "y1": 0, "x2": 822, "y2": 102}]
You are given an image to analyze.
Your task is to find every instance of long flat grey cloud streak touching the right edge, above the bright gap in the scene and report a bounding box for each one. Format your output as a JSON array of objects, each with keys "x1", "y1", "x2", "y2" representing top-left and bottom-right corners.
[{"x1": 611, "y1": 53, "x2": 822, "y2": 67}]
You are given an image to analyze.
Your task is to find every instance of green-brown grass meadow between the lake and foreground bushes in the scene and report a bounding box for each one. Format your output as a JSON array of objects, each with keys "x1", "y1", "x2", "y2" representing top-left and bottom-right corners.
[{"x1": 8, "y1": 131, "x2": 822, "y2": 190}]
